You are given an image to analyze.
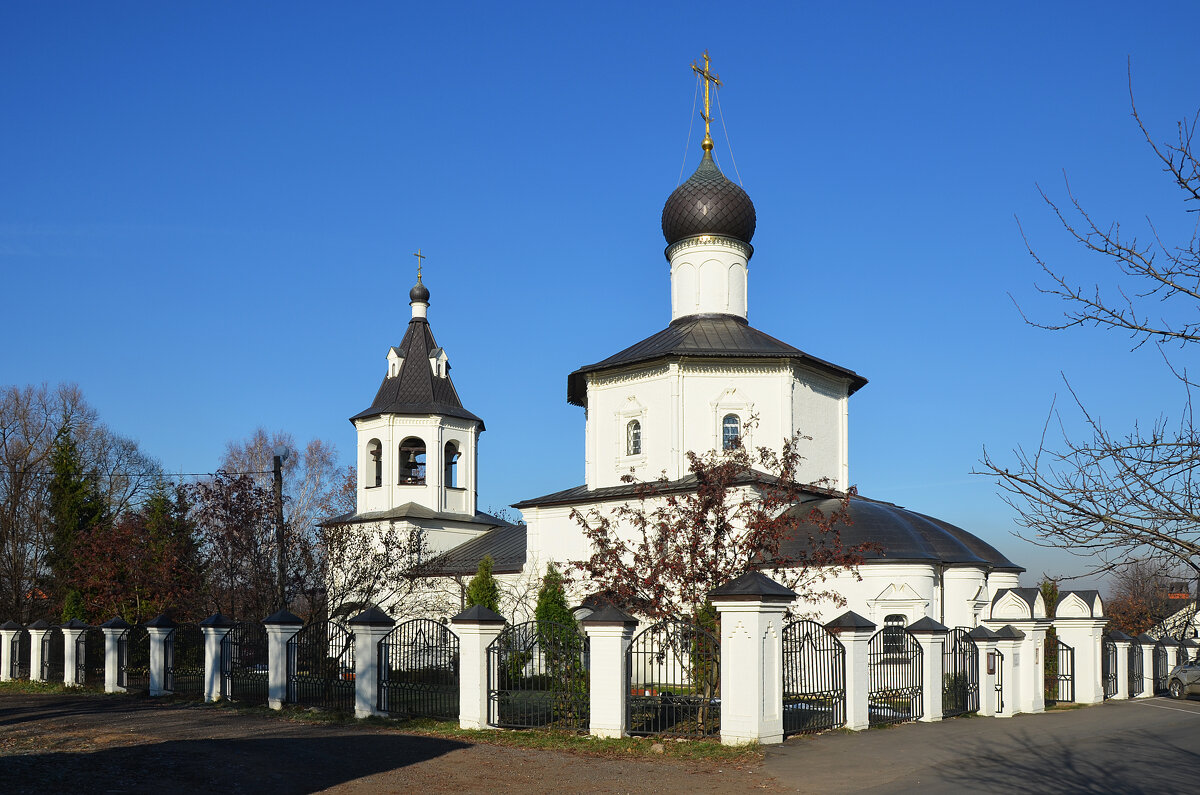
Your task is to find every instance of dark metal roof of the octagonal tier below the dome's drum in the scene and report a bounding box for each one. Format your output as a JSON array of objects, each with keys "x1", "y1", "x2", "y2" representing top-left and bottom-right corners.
[{"x1": 566, "y1": 315, "x2": 866, "y2": 406}]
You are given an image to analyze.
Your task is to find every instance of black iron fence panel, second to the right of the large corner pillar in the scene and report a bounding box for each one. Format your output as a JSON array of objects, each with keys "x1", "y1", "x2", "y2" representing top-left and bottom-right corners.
[{"x1": 866, "y1": 626, "x2": 924, "y2": 727}]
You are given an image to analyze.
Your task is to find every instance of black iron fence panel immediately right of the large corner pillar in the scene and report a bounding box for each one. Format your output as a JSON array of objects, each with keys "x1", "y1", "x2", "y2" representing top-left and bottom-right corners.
[{"x1": 784, "y1": 621, "x2": 846, "y2": 737}]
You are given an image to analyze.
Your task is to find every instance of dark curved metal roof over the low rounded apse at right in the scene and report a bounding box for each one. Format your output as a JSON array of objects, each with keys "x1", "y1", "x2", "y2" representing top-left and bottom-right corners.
[{"x1": 780, "y1": 496, "x2": 1037, "y2": 574}]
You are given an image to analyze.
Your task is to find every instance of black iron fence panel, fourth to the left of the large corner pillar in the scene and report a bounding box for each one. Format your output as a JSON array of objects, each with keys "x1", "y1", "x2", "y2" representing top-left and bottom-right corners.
[{"x1": 288, "y1": 621, "x2": 354, "y2": 712}]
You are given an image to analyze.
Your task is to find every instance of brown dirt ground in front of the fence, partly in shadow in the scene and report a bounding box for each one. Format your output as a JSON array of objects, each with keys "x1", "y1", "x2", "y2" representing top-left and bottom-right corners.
[{"x1": 0, "y1": 693, "x2": 778, "y2": 795}]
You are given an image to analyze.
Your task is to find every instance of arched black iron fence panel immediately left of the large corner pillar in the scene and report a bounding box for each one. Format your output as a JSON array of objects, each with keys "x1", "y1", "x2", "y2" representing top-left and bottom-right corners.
[{"x1": 625, "y1": 618, "x2": 721, "y2": 737}]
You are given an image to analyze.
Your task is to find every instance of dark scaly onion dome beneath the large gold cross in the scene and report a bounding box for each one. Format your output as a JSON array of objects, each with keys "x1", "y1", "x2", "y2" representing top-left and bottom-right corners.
[{"x1": 662, "y1": 151, "x2": 757, "y2": 245}]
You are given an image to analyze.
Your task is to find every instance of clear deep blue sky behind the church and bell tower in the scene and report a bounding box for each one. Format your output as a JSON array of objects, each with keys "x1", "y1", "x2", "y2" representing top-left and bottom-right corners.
[{"x1": 0, "y1": 2, "x2": 1200, "y2": 590}]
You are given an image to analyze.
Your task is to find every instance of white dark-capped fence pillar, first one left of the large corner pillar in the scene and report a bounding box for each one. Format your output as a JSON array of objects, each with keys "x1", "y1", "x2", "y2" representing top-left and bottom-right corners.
[{"x1": 581, "y1": 605, "x2": 637, "y2": 737}]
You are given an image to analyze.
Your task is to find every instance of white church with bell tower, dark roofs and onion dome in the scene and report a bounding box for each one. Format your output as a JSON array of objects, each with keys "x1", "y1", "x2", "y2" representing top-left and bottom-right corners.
[{"x1": 332, "y1": 82, "x2": 1045, "y2": 627}]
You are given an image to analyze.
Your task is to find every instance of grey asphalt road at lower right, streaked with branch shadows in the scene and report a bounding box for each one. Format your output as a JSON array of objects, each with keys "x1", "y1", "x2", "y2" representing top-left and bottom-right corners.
[{"x1": 764, "y1": 698, "x2": 1200, "y2": 793}]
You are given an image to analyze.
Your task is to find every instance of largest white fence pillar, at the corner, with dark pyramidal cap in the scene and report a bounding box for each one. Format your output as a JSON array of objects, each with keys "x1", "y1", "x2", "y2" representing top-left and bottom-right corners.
[{"x1": 708, "y1": 572, "x2": 796, "y2": 746}]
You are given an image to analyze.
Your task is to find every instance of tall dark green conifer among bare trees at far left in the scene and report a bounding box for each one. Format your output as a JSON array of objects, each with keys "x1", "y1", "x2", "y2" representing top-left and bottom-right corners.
[{"x1": 49, "y1": 423, "x2": 104, "y2": 599}]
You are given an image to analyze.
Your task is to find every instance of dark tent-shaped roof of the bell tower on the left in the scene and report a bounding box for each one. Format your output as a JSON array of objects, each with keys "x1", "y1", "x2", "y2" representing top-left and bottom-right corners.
[{"x1": 350, "y1": 317, "x2": 484, "y2": 430}]
